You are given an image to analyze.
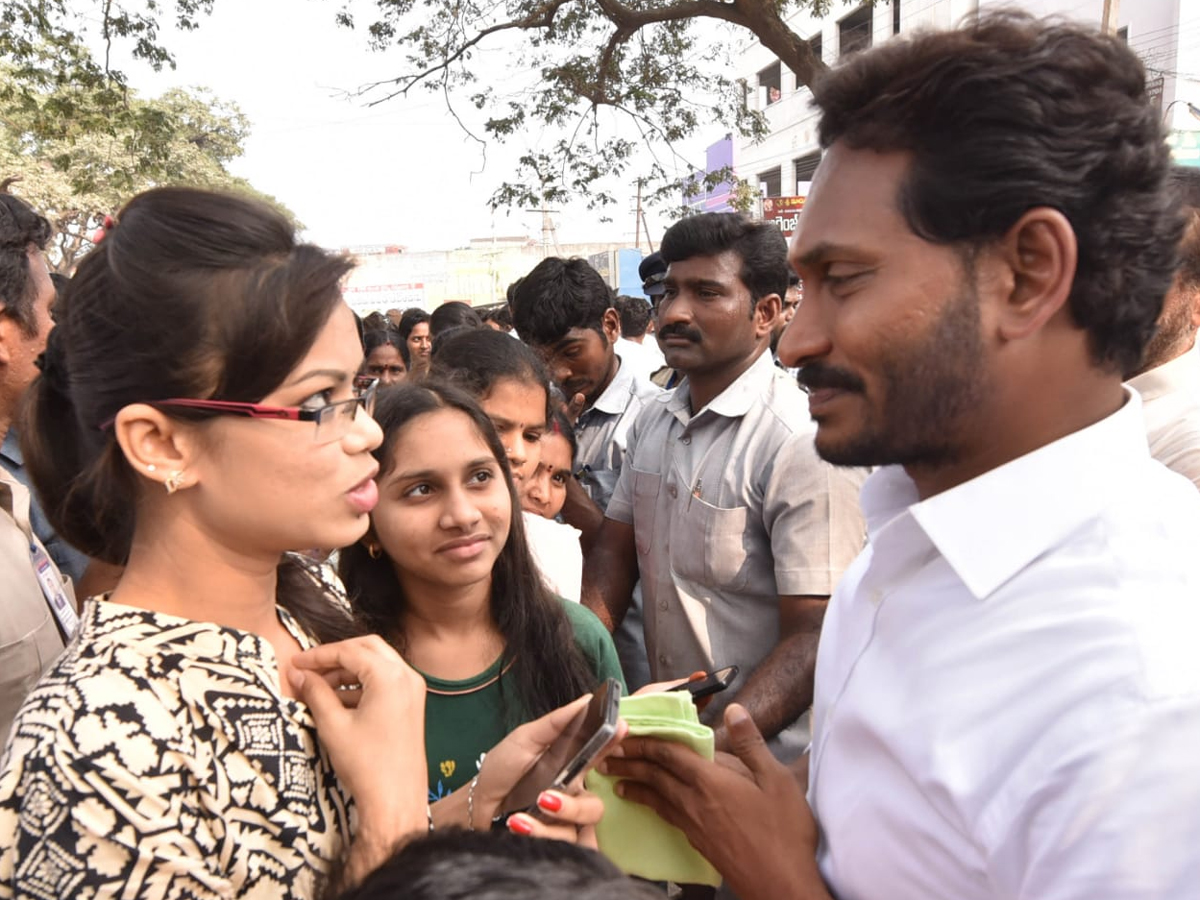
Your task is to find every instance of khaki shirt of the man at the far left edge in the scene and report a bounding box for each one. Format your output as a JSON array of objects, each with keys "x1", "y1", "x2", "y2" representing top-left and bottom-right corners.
[{"x1": 0, "y1": 467, "x2": 74, "y2": 755}]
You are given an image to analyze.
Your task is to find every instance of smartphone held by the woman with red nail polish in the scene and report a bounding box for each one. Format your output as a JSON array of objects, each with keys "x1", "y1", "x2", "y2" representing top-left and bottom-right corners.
[{"x1": 492, "y1": 678, "x2": 620, "y2": 828}]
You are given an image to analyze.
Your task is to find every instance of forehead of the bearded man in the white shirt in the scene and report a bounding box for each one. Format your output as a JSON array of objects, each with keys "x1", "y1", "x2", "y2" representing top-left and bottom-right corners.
[{"x1": 787, "y1": 142, "x2": 917, "y2": 271}]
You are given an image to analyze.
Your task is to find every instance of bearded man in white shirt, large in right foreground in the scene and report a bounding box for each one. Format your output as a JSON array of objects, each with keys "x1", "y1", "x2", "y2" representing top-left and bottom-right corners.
[{"x1": 606, "y1": 13, "x2": 1200, "y2": 900}]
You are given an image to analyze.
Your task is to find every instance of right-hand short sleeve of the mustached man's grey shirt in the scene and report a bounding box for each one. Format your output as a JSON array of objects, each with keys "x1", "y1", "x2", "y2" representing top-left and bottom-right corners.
[{"x1": 762, "y1": 433, "x2": 866, "y2": 596}]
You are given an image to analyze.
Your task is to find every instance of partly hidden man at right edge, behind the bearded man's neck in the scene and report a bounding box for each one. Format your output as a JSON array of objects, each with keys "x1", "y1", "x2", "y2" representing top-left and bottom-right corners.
[{"x1": 1129, "y1": 167, "x2": 1200, "y2": 487}]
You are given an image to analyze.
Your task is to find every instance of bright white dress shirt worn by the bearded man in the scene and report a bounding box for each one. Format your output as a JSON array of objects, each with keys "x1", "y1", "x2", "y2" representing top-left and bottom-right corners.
[{"x1": 809, "y1": 392, "x2": 1200, "y2": 900}]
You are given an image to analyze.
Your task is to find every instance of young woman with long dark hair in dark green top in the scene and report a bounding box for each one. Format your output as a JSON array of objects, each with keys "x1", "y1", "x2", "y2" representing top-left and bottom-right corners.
[{"x1": 338, "y1": 380, "x2": 622, "y2": 800}]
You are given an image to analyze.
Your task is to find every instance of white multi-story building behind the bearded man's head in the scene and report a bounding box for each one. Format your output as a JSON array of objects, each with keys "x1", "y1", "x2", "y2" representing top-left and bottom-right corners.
[{"x1": 732, "y1": 0, "x2": 1200, "y2": 212}]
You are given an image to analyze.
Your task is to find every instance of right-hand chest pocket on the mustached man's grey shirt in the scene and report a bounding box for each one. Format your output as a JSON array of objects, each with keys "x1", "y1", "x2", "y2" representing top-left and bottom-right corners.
[{"x1": 672, "y1": 497, "x2": 750, "y2": 593}]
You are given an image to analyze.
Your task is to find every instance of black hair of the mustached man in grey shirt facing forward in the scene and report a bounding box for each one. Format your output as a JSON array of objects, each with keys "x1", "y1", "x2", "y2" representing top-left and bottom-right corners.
[{"x1": 659, "y1": 212, "x2": 791, "y2": 316}]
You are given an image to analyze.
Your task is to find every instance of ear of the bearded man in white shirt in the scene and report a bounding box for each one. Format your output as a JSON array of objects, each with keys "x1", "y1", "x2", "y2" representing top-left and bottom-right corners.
[{"x1": 996, "y1": 206, "x2": 1079, "y2": 341}]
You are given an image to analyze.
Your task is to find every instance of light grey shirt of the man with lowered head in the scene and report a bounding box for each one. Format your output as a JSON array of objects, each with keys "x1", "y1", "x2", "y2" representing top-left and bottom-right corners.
[{"x1": 575, "y1": 354, "x2": 662, "y2": 509}]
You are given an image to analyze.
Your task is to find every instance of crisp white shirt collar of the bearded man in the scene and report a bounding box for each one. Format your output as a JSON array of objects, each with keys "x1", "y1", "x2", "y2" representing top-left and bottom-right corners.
[{"x1": 862, "y1": 389, "x2": 1150, "y2": 600}]
